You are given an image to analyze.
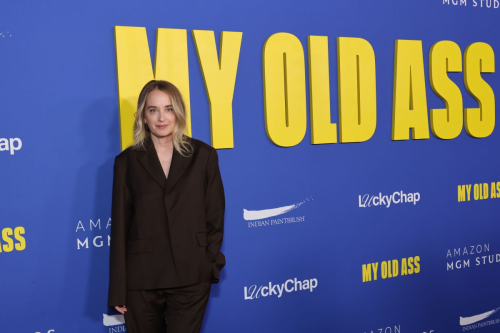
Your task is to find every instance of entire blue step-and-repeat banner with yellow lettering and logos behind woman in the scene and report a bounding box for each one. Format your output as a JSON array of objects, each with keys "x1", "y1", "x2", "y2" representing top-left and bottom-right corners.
[{"x1": 0, "y1": 0, "x2": 500, "y2": 333}]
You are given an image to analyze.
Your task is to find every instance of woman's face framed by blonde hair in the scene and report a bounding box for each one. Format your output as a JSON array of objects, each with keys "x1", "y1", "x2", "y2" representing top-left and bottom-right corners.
[{"x1": 144, "y1": 89, "x2": 175, "y2": 138}]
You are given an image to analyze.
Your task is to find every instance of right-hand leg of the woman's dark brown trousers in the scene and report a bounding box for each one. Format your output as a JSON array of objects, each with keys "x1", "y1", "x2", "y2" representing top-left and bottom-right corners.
[{"x1": 164, "y1": 281, "x2": 212, "y2": 333}]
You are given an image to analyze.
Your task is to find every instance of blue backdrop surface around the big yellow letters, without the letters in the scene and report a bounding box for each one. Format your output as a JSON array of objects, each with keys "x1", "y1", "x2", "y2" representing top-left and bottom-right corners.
[{"x1": 0, "y1": 0, "x2": 500, "y2": 333}]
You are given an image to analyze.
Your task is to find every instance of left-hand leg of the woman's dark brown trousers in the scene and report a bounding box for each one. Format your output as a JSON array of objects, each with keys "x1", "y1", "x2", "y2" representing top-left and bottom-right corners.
[{"x1": 125, "y1": 290, "x2": 166, "y2": 333}]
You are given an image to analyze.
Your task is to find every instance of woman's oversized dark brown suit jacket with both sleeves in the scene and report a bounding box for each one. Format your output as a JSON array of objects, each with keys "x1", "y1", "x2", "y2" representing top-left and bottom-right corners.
[{"x1": 108, "y1": 137, "x2": 225, "y2": 306}]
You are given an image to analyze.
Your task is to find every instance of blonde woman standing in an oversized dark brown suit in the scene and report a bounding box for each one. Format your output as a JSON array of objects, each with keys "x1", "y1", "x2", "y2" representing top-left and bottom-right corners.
[{"x1": 108, "y1": 80, "x2": 225, "y2": 333}]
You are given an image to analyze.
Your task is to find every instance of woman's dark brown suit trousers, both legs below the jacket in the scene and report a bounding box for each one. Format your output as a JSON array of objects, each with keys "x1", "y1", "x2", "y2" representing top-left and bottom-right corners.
[{"x1": 125, "y1": 281, "x2": 212, "y2": 333}]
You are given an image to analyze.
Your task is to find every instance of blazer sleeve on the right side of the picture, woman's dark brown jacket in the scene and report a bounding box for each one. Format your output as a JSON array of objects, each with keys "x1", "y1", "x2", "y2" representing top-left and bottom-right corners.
[{"x1": 205, "y1": 148, "x2": 226, "y2": 283}]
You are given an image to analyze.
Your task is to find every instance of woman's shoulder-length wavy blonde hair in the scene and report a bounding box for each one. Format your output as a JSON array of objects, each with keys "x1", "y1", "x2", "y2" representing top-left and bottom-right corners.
[{"x1": 132, "y1": 80, "x2": 193, "y2": 156}]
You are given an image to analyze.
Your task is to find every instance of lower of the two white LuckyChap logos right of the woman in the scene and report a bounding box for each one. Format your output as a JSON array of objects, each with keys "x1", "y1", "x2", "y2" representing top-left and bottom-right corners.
[{"x1": 243, "y1": 278, "x2": 318, "y2": 300}]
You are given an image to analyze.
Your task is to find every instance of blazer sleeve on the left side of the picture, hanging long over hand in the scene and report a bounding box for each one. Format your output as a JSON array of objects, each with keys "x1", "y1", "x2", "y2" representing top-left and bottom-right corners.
[{"x1": 108, "y1": 157, "x2": 132, "y2": 307}]
